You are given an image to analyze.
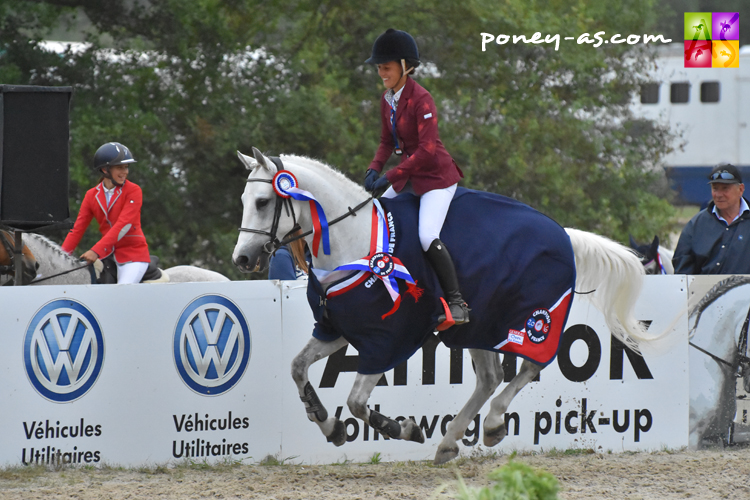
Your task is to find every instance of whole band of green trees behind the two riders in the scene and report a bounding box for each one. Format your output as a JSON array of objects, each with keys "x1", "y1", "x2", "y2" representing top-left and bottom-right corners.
[{"x1": 0, "y1": 0, "x2": 674, "y2": 279}]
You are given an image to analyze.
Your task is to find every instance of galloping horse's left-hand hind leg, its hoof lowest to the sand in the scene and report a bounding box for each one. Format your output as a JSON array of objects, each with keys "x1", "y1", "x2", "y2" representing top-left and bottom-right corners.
[{"x1": 434, "y1": 349, "x2": 503, "y2": 465}]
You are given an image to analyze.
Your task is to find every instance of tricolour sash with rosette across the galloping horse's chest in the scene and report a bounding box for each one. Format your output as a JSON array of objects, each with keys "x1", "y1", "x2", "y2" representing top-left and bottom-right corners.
[{"x1": 321, "y1": 200, "x2": 416, "y2": 319}]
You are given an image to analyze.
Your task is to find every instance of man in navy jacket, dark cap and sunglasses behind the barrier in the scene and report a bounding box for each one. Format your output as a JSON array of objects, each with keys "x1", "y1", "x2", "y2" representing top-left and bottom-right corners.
[{"x1": 672, "y1": 164, "x2": 750, "y2": 274}]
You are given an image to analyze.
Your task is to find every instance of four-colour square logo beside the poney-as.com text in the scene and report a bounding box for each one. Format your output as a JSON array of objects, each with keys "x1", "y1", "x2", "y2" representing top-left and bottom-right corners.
[{"x1": 683, "y1": 12, "x2": 740, "y2": 68}]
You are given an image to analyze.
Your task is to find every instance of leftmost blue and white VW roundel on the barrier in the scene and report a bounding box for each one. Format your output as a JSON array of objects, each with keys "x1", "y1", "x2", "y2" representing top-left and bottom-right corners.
[{"x1": 23, "y1": 299, "x2": 104, "y2": 403}]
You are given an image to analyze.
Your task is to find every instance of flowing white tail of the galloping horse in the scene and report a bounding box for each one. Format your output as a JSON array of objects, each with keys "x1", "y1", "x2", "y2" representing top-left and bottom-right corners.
[{"x1": 565, "y1": 228, "x2": 656, "y2": 352}]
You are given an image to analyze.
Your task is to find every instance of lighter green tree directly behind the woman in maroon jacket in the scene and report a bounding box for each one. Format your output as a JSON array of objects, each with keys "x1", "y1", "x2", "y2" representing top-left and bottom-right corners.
[{"x1": 277, "y1": 0, "x2": 674, "y2": 241}]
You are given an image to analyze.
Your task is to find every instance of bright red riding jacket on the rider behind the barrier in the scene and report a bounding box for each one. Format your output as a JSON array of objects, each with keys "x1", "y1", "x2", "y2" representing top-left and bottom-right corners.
[{"x1": 62, "y1": 181, "x2": 149, "y2": 264}]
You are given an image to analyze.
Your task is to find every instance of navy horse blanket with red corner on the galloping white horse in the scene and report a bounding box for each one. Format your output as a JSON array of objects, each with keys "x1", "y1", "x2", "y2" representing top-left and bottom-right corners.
[{"x1": 308, "y1": 188, "x2": 575, "y2": 374}]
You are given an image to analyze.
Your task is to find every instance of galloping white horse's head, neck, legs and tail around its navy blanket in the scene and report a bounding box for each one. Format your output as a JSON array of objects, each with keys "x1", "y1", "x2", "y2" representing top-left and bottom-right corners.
[{"x1": 233, "y1": 148, "x2": 664, "y2": 464}]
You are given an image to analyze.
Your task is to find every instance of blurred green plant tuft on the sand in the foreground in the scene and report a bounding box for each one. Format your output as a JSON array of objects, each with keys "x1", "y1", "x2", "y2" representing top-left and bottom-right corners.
[{"x1": 456, "y1": 456, "x2": 559, "y2": 500}]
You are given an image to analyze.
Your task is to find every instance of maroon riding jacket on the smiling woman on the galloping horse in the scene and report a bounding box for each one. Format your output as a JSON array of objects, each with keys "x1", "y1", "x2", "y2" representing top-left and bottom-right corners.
[{"x1": 368, "y1": 77, "x2": 463, "y2": 196}]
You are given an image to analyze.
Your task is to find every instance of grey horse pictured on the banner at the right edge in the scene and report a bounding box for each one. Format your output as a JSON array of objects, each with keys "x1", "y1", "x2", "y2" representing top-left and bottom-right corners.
[{"x1": 688, "y1": 276, "x2": 750, "y2": 449}]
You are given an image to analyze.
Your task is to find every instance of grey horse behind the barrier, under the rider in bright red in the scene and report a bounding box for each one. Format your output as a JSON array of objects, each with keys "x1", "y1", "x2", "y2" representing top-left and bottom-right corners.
[{"x1": 22, "y1": 233, "x2": 229, "y2": 286}]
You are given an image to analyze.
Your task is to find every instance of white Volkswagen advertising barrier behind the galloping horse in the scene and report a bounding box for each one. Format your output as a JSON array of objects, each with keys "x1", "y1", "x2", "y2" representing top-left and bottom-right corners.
[{"x1": 0, "y1": 276, "x2": 689, "y2": 465}]
